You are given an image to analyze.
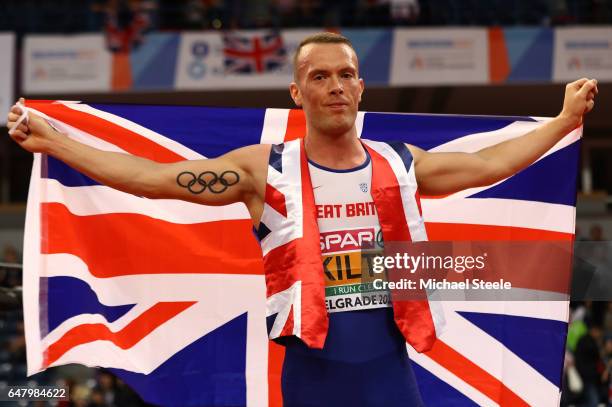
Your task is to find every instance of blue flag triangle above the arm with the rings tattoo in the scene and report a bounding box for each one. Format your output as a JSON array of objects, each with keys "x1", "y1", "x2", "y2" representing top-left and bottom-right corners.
[{"x1": 92, "y1": 104, "x2": 265, "y2": 158}]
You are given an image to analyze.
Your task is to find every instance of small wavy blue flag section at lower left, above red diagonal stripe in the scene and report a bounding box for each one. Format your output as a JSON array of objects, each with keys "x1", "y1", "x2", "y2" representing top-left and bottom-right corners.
[{"x1": 40, "y1": 277, "x2": 135, "y2": 332}]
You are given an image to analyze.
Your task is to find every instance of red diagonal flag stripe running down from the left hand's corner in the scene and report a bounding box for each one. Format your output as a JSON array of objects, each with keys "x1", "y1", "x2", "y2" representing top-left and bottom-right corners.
[{"x1": 30, "y1": 103, "x2": 185, "y2": 163}]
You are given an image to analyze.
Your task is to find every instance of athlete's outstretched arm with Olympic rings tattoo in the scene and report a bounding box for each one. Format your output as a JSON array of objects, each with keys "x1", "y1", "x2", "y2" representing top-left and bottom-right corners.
[{"x1": 8, "y1": 100, "x2": 269, "y2": 213}]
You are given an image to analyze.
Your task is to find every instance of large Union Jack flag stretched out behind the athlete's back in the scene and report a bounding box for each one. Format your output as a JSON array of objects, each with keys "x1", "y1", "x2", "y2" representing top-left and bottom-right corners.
[{"x1": 24, "y1": 101, "x2": 582, "y2": 406}]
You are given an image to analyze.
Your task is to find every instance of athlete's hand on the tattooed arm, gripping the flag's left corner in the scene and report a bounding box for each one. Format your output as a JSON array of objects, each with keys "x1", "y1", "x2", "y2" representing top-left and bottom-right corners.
[{"x1": 6, "y1": 98, "x2": 57, "y2": 153}]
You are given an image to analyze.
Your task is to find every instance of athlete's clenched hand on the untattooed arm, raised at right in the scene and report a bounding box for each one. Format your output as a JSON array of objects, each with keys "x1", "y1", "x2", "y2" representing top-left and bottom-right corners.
[{"x1": 559, "y1": 78, "x2": 599, "y2": 129}]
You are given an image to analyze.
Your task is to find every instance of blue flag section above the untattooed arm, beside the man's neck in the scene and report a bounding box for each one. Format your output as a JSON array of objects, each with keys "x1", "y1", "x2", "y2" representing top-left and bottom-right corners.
[{"x1": 361, "y1": 113, "x2": 534, "y2": 150}]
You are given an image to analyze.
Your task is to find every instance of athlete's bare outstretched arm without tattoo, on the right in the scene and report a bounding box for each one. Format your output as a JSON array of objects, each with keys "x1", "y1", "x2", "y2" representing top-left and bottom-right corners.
[{"x1": 408, "y1": 78, "x2": 597, "y2": 195}]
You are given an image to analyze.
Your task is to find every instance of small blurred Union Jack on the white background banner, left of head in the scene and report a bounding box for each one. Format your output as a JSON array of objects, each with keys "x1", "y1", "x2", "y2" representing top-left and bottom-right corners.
[{"x1": 223, "y1": 33, "x2": 287, "y2": 74}]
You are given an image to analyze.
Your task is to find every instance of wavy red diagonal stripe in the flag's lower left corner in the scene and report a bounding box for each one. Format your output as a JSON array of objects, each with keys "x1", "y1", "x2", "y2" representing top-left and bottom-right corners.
[{"x1": 43, "y1": 301, "x2": 195, "y2": 367}]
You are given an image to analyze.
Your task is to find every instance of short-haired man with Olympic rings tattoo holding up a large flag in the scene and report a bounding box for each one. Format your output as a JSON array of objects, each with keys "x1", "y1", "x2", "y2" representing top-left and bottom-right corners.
[{"x1": 8, "y1": 33, "x2": 597, "y2": 406}]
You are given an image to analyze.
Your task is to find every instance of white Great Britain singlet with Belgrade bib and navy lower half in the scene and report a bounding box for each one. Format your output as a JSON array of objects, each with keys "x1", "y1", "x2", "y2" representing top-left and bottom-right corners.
[{"x1": 282, "y1": 150, "x2": 423, "y2": 407}]
